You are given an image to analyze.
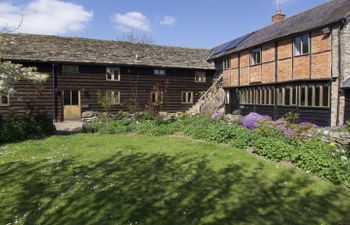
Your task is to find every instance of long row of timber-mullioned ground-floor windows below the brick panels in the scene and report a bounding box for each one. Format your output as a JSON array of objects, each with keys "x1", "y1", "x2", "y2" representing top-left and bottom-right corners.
[{"x1": 240, "y1": 84, "x2": 330, "y2": 107}]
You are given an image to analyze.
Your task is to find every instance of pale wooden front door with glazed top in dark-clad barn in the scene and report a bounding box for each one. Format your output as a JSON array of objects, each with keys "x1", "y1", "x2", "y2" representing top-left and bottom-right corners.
[{"x1": 63, "y1": 90, "x2": 81, "y2": 120}]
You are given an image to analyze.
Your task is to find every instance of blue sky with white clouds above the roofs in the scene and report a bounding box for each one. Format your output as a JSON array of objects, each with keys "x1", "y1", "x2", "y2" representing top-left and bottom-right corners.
[{"x1": 0, "y1": 0, "x2": 329, "y2": 48}]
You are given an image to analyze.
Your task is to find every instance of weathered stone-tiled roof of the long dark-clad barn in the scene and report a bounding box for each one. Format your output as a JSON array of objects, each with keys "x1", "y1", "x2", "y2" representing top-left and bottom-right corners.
[{"x1": 0, "y1": 34, "x2": 214, "y2": 69}]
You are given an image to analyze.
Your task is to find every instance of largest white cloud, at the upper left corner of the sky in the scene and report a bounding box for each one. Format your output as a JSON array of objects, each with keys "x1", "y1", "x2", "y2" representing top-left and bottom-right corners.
[{"x1": 0, "y1": 0, "x2": 93, "y2": 34}]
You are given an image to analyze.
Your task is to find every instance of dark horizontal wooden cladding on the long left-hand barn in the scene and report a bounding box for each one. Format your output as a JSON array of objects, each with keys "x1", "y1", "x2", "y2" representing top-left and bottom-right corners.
[{"x1": 0, "y1": 63, "x2": 214, "y2": 120}]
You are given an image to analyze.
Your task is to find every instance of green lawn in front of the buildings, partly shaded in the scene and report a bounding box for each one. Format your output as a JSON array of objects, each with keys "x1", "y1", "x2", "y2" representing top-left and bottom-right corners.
[{"x1": 0, "y1": 134, "x2": 350, "y2": 225}]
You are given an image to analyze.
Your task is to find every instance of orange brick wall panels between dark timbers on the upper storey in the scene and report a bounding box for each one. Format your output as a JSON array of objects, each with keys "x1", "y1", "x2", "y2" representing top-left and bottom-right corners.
[{"x1": 224, "y1": 26, "x2": 332, "y2": 87}]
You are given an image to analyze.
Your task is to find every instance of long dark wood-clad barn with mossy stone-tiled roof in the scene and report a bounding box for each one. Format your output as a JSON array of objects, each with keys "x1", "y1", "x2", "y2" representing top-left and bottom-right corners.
[{"x1": 0, "y1": 34, "x2": 215, "y2": 121}]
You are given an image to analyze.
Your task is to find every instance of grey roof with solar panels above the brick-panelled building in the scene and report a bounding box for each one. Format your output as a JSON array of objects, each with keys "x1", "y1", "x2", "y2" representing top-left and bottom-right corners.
[{"x1": 209, "y1": 0, "x2": 350, "y2": 60}]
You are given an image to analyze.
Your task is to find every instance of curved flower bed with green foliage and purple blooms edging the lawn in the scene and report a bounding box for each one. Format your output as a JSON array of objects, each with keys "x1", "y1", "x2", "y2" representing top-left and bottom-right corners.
[{"x1": 86, "y1": 113, "x2": 350, "y2": 187}]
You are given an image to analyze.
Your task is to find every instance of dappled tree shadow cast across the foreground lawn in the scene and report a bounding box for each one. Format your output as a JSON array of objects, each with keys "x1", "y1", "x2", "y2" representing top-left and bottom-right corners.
[{"x1": 0, "y1": 153, "x2": 350, "y2": 225}]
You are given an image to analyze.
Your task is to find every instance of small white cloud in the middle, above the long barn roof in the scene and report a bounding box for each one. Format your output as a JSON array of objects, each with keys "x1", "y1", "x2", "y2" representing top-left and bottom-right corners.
[{"x1": 113, "y1": 12, "x2": 151, "y2": 32}]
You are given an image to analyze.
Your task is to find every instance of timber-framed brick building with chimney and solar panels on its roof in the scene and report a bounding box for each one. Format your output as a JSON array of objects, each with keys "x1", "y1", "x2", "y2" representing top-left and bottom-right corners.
[{"x1": 209, "y1": 0, "x2": 350, "y2": 126}]
